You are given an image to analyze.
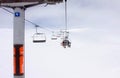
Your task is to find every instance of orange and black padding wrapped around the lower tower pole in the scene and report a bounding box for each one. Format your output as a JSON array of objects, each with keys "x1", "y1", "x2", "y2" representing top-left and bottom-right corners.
[{"x1": 14, "y1": 44, "x2": 24, "y2": 76}]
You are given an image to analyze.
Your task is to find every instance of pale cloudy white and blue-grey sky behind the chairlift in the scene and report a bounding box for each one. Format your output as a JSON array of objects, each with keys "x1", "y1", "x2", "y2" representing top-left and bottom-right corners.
[{"x1": 0, "y1": 0, "x2": 120, "y2": 78}]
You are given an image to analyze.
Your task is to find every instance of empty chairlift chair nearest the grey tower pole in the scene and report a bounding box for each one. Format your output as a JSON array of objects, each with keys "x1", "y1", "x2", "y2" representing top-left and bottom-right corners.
[{"x1": 33, "y1": 33, "x2": 46, "y2": 43}]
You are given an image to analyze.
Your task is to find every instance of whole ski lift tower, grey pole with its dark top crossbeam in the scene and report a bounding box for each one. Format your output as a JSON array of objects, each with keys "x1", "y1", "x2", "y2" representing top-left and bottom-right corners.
[{"x1": 0, "y1": 0, "x2": 63, "y2": 78}]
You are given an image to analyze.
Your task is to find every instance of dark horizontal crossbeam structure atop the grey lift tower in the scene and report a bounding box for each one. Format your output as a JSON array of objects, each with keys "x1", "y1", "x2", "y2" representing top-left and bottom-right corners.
[{"x1": 0, "y1": 0, "x2": 63, "y2": 8}]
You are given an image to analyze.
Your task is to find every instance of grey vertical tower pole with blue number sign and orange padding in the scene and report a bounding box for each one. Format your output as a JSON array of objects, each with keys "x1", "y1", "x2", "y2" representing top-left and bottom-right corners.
[{"x1": 13, "y1": 7, "x2": 25, "y2": 78}]
